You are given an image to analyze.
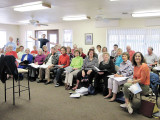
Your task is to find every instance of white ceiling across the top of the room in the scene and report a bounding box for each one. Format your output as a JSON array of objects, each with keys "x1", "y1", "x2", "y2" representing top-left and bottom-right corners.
[{"x1": 0, "y1": 0, "x2": 160, "y2": 24}]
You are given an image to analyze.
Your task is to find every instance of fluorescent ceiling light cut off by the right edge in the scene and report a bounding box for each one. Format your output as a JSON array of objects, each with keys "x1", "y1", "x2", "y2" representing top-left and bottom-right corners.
[{"x1": 132, "y1": 11, "x2": 160, "y2": 17}]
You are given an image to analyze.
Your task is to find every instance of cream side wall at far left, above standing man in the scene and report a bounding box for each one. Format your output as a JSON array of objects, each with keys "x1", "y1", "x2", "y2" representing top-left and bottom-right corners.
[{"x1": 0, "y1": 24, "x2": 20, "y2": 45}]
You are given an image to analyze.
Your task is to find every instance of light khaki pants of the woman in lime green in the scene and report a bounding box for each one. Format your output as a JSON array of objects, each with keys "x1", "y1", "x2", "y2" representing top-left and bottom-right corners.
[{"x1": 65, "y1": 70, "x2": 80, "y2": 86}]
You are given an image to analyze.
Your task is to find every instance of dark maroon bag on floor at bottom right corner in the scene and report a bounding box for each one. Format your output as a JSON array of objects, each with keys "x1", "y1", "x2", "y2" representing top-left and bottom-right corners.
[{"x1": 139, "y1": 99, "x2": 159, "y2": 117}]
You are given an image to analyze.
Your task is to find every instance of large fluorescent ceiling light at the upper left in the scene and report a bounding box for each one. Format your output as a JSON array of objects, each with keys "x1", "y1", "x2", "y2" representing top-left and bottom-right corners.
[{"x1": 14, "y1": 1, "x2": 51, "y2": 12}]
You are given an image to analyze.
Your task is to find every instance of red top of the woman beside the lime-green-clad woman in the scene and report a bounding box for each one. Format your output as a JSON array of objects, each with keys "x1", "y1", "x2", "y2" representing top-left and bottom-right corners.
[{"x1": 58, "y1": 54, "x2": 70, "y2": 68}]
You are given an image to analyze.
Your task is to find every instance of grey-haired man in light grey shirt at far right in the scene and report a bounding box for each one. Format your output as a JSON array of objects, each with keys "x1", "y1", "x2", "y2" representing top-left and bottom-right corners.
[{"x1": 144, "y1": 47, "x2": 158, "y2": 67}]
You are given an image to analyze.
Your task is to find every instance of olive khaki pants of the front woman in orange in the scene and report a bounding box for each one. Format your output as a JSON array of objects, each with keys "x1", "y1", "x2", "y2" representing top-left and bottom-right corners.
[{"x1": 123, "y1": 83, "x2": 149, "y2": 99}]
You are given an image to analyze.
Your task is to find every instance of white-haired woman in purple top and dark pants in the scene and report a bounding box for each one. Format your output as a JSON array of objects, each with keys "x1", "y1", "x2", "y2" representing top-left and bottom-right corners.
[{"x1": 29, "y1": 48, "x2": 46, "y2": 81}]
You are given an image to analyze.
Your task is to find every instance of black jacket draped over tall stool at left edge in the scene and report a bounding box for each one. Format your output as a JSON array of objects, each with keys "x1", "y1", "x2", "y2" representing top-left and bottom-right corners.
[{"x1": 0, "y1": 55, "x2": 18, "y2": 83}]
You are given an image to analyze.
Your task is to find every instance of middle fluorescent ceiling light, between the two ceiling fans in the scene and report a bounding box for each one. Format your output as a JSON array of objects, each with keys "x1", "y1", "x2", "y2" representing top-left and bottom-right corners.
[{"x1": 63, "y1": 15, "x2": 90, "y2": 21}]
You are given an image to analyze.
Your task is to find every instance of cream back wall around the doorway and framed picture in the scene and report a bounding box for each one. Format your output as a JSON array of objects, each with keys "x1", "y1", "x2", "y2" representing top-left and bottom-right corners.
[{"x1": 20, "y1": 21, "x2": 106, "y2": 52}]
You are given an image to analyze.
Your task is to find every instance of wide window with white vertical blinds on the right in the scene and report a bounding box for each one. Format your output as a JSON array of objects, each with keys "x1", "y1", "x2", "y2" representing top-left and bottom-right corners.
[{"x1": 107, "y1": 28, "x2": 160, "y2": 56}]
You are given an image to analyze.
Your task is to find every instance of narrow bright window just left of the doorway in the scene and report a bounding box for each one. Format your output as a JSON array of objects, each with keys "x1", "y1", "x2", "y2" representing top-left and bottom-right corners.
[{"x1": 26, "y1": 31, "x2": 34, "y2": 51}]
